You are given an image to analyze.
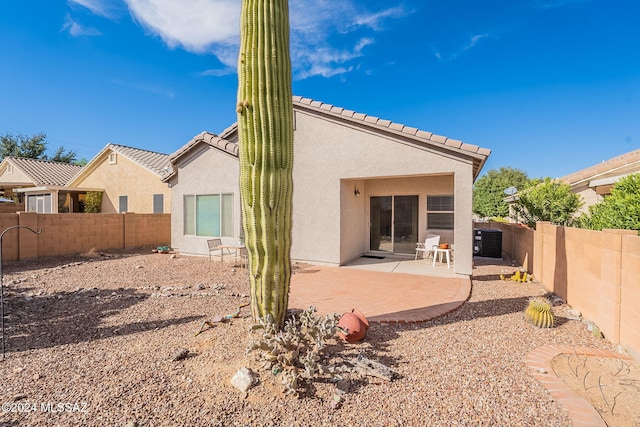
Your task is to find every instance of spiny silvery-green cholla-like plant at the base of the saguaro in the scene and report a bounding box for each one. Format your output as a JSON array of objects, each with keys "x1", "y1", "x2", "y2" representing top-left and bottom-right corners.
[{"x1": 247, "y1": 307, "x2": 348, "y2": 394}]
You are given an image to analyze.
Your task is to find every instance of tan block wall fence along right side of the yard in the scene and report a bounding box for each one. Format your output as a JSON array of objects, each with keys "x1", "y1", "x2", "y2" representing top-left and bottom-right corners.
[{"x1": 474, "y1": 222, "x2": 640, "y2": 360}]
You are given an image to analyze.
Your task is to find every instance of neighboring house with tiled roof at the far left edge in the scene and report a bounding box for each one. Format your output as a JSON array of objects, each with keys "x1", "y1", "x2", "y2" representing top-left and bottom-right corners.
[{"x1": 0, "y1": 157, "x2": 81, "y2": 213}]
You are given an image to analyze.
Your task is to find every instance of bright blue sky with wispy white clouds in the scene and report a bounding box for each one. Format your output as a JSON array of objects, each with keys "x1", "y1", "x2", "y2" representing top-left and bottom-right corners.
[{"x1": 0, "y1": 0, "x2": 640, "y2": 178}]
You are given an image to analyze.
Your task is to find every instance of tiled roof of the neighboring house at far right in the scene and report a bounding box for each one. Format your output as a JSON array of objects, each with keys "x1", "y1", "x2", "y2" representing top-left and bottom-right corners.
[{"x1": 560, "y1": 149, "x2": 640, "y2": 187}]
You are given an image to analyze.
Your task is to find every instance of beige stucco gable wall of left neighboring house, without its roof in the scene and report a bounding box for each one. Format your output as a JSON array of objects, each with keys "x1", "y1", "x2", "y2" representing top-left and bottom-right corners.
[{"x1": 71, "y1": 150, "x2": 171, "y2": 213}]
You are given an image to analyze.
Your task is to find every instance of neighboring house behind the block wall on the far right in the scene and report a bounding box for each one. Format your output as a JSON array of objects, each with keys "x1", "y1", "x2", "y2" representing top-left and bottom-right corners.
[{"x1": 560, "y1": 149, "x2": 640, "y2": 214}]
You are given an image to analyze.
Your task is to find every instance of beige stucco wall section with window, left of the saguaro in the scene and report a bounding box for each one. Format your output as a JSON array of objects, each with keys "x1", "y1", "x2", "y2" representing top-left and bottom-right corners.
[{"x1": 169, "y1": 144, "x2": 242, "y2": 255}]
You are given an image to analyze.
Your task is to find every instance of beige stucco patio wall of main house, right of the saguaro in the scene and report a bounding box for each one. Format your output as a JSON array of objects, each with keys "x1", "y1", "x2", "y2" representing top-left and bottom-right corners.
[{"x1": 292, "y1": 111, "x2": 473, "y2": 274}]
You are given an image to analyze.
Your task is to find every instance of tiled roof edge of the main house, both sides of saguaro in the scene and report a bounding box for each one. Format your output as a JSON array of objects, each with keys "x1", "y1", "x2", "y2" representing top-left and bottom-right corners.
[{"x1": 163, "y1": 96, "x2": 491, "y2": 181}]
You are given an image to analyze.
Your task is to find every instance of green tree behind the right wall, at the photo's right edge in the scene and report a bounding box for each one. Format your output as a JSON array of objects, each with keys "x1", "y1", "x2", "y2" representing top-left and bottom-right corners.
[{"x1": 580, "y1": 173, "x2": 640, "y2": 232}]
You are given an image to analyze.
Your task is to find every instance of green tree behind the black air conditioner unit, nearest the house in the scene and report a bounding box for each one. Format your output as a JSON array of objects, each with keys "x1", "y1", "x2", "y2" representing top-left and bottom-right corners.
[{"x1": 473, "y1": 167, "x2": 530, "y2": 218}]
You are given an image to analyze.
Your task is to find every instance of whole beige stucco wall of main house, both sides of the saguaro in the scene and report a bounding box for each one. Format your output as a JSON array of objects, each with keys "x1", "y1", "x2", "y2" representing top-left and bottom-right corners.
[{"x1": 170, "y1": 111, "x2": 480, "y2": 275}]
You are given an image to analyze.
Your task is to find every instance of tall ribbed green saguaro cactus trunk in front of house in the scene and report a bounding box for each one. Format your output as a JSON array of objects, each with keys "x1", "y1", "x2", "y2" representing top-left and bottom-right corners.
[{"x1": 237, "y1": 0, "x2": 293, "y2": 325}]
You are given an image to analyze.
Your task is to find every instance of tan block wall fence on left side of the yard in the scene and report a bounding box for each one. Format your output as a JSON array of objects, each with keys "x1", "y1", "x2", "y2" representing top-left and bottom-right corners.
[{"x1": 0, "y1": 212, "x2": 171, "y2": 261}]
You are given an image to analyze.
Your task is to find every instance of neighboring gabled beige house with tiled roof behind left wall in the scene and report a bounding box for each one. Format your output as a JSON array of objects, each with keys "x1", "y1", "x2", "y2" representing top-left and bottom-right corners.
[{"x1": 67, "y1": 144, "x2": 171, "y2": 213}]
